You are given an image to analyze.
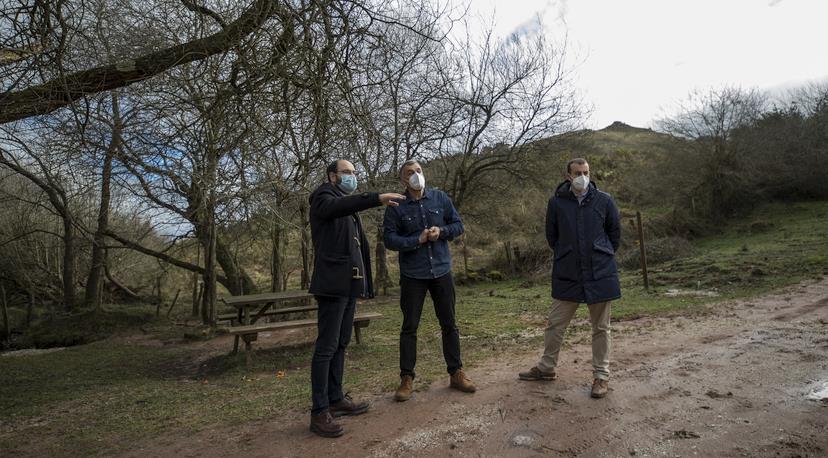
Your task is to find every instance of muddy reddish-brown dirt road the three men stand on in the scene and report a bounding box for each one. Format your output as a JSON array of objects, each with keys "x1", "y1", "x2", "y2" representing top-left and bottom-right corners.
[{"x1": 126, "y1": 279, "x2": 828, "y2": 457}]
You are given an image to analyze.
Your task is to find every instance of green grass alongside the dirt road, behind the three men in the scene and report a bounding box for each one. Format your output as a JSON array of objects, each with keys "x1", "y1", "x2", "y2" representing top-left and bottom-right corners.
[{"x1": 0, "y1": 202, "x2": 828, "y2": 456}]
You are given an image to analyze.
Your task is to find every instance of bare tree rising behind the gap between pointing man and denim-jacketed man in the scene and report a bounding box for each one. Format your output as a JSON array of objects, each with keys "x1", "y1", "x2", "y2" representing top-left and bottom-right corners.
[{"x1": 342, "y1": 16, "x2": 450, "y2": 291}]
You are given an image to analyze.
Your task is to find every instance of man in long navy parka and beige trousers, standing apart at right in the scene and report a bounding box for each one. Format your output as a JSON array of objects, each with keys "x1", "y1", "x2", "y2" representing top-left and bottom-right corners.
[{"x1": 519, "y1": 158, "x2": 621, "y2": 398}]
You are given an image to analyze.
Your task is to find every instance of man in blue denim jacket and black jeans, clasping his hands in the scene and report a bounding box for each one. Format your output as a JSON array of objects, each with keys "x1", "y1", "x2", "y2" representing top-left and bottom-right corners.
[{"x1": 383, "y1": 160, "x2": 476, "y2": 401}]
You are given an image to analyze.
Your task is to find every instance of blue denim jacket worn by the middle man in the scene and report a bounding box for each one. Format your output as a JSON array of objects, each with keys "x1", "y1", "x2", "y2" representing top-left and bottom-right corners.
[{"x1": 382, "y1": 188, "x2": 463, "y2": 279}]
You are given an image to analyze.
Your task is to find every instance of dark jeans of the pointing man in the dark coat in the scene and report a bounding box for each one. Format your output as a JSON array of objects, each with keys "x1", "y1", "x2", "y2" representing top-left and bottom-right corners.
[{"x1": 311, "y1": 296, "x2": 356, "y2": 415}]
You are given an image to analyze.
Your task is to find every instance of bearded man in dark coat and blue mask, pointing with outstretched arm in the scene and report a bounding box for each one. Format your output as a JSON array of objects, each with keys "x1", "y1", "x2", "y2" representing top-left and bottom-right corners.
[{"x1": 310, "y1": 160, "x2": 405, "y2": 437}]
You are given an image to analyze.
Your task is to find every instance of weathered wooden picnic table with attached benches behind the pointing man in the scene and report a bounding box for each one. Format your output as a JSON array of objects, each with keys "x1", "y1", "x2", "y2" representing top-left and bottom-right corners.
[{"x1": 217, "y1": 291, "x2": 382, "y2": 363}]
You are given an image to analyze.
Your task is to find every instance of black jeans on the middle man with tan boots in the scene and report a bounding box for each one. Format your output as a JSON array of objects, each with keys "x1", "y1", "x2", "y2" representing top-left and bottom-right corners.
[{"x1": 400, "y1": 272, "x2": 463, "y2": 378}]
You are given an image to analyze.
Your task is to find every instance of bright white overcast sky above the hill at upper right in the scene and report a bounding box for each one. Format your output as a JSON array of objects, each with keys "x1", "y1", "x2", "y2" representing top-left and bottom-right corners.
[{"x1": 470, "y1": 0, "x2": 828, "y2": 129}]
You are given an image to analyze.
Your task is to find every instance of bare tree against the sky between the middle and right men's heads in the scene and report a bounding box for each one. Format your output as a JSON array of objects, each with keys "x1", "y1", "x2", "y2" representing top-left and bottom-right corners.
[{"x1": 430, "y1": 19, "x2": 585, "y2": 208}]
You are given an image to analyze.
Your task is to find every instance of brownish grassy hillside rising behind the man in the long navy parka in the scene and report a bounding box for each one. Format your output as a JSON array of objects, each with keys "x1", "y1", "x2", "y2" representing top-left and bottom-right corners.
[{"x1": 456, "y1": 122, "x2": 696, "y2": 268}]
